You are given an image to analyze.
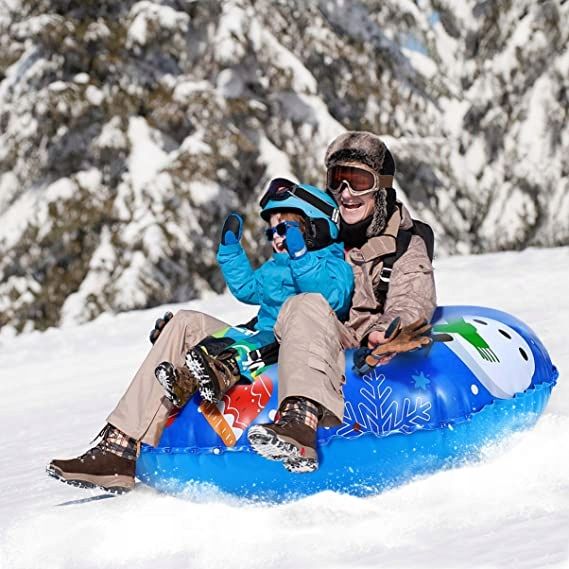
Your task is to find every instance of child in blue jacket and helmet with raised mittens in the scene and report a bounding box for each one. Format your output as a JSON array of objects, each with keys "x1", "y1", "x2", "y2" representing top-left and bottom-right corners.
[{"x1": 156, "y1": 178, "x2": 354, "y2": 414}]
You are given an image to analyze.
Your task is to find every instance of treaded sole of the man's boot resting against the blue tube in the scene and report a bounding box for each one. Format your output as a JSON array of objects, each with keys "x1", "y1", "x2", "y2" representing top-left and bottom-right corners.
[{"x1": 247, "y1": 425, "x2": 318, "y2": 474}]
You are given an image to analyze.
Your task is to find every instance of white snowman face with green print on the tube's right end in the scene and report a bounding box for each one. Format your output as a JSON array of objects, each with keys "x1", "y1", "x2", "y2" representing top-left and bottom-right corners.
[{"x1": 434, "y1": 316, "x2": 535, "y2": 399}]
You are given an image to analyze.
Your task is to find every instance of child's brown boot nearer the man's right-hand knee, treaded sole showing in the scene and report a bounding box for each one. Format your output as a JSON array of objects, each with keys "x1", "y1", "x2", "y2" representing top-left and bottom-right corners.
[{"x1": 186, "y1": 346, "x2": 241, "y2": 403}]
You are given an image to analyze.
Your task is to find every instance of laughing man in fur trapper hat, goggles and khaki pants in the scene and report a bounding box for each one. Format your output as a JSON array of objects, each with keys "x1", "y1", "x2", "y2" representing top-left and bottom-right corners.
[{"x1": 48, "y1": 132, "x2": 435, "y2": 492}]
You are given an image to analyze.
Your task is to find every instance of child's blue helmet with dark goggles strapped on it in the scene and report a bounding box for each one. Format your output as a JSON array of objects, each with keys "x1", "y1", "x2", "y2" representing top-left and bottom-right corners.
[{"x1": 261, "y1": 178, "x2": 340, "y2": 250}]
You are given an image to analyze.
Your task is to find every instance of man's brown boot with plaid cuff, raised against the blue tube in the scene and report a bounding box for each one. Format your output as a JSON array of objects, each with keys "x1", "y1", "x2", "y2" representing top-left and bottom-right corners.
[{"x1": 247, "y1": 397, "x2": 320, "y2": 473}]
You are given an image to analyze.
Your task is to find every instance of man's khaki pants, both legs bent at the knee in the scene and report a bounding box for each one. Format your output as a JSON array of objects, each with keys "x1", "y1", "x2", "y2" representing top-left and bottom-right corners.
[{"x1": 107, "y1": 293, "x2": 356, "y2": 446}]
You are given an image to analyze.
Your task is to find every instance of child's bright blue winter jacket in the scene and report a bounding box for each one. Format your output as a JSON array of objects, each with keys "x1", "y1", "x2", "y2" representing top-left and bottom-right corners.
[{"x1": 217, "y1": 243, "x2": 354, "y2": 331}]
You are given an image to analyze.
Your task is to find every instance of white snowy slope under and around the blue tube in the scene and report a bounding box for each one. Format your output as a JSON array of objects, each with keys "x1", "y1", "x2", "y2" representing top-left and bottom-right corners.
[{"x1": 0, "y1": 248, "x2": 569, "y2": 569}]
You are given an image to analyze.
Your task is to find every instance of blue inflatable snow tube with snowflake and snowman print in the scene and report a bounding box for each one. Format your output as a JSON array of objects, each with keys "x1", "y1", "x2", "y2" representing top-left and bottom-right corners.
[{"x1": 137, "y1": 306, "x2": 558, "y2": 501}]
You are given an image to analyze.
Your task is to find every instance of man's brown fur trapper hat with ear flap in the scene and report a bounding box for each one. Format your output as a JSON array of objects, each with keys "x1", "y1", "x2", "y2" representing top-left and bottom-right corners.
[{"x1": 325, "y1": 131, "x2": 395, "y2": 238}]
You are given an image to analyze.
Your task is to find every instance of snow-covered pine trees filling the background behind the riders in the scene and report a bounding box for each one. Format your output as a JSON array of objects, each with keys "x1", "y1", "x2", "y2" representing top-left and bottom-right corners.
[{"x1": 0, "y1": 0, "x2": 569, "y2": 330}]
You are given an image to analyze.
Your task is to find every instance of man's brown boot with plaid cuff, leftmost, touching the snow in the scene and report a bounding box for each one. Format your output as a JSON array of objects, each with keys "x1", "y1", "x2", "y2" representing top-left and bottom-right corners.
[{"x1": 47, "y1": 425, "x2": 137, "y2": 494}]
